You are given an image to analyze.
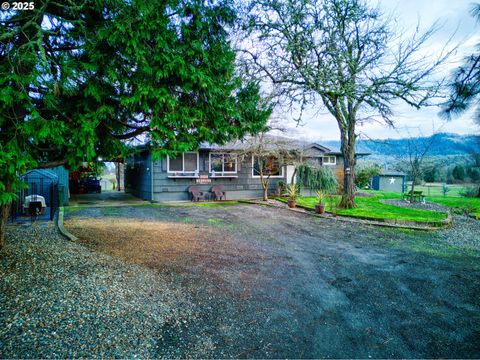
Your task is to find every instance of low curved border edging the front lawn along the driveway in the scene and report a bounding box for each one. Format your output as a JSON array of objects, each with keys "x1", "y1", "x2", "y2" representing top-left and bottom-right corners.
[{"x1": 245, "y1": 200, "x2": 453, "y2": 231}]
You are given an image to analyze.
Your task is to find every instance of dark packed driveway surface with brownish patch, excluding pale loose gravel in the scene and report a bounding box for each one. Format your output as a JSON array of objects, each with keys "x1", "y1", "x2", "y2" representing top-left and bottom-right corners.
[{"x1": 59, "y1": 205, "x2": 480, "y2": 358}]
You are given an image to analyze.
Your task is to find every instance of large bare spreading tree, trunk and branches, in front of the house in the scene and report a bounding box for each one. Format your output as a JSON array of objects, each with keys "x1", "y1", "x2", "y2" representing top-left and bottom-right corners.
[{"x1": 243, "y1": 0, "x2": 449, "y2": 208}]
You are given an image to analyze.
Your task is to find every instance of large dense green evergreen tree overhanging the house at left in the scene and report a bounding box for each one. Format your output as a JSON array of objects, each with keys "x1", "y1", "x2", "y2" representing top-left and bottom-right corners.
[{"x1": 0, "y1": 0, "x2": 270, "y2": 247}]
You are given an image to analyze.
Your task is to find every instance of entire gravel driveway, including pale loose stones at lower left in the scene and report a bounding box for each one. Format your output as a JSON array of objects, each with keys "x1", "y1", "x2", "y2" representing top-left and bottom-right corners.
[{"x1": 0, "y1": 205, "x2": 480, "y2": 358}]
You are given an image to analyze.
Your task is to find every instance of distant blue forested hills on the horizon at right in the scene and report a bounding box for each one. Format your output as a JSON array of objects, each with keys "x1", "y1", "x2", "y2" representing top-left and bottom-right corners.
[{"x1": 319, "y1": 133, "x2": 480, "y2": 158}]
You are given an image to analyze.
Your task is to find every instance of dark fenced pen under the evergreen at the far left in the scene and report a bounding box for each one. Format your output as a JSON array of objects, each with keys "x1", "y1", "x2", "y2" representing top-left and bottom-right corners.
[{"x1": 10, "y1": 176, "x2": 60, "y2": 223}]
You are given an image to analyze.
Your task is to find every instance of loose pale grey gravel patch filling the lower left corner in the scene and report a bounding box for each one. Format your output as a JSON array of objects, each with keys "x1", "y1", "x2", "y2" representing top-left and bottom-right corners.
[{"x1": 0, "y1": 226, "x2": 199, "y2": 358}]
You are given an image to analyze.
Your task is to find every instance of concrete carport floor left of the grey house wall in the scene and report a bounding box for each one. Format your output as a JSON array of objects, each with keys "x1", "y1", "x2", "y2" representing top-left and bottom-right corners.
[{"x1": 70, "y1": 191, "x2": 149, "y2": 207}]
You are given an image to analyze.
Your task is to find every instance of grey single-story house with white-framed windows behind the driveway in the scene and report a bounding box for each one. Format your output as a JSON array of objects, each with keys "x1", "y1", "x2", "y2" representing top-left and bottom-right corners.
[{"x1": 125, "y1": 136, "x2": 368, "y2": 201}]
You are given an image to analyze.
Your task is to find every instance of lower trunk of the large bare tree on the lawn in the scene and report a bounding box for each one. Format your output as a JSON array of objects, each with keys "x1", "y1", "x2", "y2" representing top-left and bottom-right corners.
[{"x1": 338, "y1": 126, "x2": 357, "y2": 209}]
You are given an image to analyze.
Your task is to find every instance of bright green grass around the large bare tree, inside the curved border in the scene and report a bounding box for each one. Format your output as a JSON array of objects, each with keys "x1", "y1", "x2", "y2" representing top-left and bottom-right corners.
[{"x1": 280, "y1": 191, "x2": 447, "y2": 222}]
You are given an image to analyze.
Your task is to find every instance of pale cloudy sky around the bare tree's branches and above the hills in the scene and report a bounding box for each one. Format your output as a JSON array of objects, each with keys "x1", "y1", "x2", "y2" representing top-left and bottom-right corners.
[{"x1": 282, "y1": 0, "x2": 480, "y2": 140}]
